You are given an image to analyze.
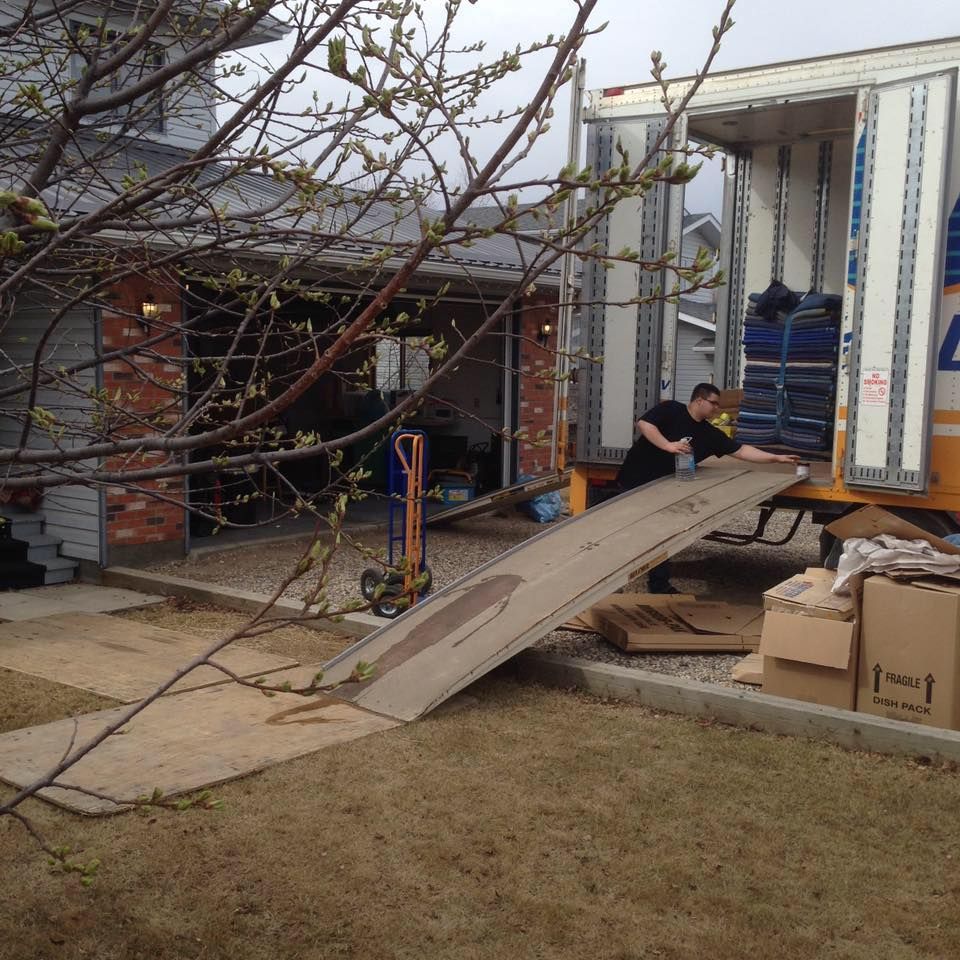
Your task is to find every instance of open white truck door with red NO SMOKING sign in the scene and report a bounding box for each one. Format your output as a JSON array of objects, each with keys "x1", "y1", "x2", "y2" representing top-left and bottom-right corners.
[{"x1": 844, "y1": 70, "x2": 957, "y2": 493}]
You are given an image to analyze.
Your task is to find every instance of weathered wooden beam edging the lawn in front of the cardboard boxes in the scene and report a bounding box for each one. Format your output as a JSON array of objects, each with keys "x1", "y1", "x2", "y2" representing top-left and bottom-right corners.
[{"x1": 511, "y1": 650, "x2": 960, "y2": 763}]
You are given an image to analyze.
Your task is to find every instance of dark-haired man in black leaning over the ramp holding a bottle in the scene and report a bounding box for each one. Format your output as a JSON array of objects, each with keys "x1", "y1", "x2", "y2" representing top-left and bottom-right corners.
[{"x1": 617, "y1": 383, "x2": 800, "y2": 593}]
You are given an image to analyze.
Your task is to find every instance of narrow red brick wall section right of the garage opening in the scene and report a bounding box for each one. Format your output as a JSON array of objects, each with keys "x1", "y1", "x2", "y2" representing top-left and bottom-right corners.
[{"x1": 518, "y1": 299, "x2": 557, "y2": 476}]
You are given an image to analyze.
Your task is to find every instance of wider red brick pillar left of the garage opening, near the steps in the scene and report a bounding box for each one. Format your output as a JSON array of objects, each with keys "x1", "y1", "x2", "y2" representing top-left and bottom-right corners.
[{"x1": 102, "y1": 278, "x2": 186, "y2": 563}]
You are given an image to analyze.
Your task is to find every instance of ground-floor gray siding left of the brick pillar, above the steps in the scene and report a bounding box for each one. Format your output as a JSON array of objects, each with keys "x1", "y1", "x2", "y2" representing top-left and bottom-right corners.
[{"x1": 0, "y1": 297, "x2": 100, "y2": 562}]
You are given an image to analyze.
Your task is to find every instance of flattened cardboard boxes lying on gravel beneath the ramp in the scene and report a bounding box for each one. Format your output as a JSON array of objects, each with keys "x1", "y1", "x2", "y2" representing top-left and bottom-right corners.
[{"x1": 594, "y1": 594, "x2": 762, "y2": 653}]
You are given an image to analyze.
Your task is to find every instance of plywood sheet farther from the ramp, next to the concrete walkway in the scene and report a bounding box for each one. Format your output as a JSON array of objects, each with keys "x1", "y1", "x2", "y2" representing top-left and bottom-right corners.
[{"x1": 0, "y1": 613, "x2": 297, "y2": 703}]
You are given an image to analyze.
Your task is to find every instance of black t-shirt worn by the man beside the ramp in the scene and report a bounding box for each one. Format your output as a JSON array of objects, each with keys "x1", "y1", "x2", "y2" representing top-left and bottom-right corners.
[{"x1": 617, "y1": 400, "x2": 741, "y2": 490}]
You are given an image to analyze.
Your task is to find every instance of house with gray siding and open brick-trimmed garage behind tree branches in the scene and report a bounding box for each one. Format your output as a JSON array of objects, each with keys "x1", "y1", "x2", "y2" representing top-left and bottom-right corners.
[{"x1": 0, "y1": 4, "x2": 559, "y2": 587}]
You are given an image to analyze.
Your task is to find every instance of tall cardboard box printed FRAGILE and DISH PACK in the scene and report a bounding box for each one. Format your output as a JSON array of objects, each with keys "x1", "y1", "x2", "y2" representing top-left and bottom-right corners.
[{"x1": 857, "y1": 577, "x2": 960, "y2": 730}]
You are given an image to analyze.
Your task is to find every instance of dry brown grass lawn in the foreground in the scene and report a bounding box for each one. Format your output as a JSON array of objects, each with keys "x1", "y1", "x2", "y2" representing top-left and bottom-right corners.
[{"x1": 0, "y1": 648, "x2": 960, "y2": 960}]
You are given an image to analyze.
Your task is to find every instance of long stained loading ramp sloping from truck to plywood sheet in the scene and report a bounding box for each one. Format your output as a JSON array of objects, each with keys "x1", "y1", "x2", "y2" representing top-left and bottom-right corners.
[{"x1": 325, "y1": 461, "x2": 796, "y2": 720}]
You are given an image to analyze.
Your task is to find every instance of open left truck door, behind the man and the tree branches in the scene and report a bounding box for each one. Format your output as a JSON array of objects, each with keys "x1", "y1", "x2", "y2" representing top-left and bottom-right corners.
[{"x1": 577, "y1": 114, "x2": 686, "y2": 463}]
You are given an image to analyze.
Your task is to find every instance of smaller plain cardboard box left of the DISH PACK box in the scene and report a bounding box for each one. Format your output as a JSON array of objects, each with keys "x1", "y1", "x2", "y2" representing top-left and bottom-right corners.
[{"x1": 760, "y1": 610, "x2": 857, "y2": 710}]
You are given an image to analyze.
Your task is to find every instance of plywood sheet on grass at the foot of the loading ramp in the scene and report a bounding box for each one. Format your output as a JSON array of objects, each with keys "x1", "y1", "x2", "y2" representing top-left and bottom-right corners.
[{"x1": 0, "y1": 684, "x2": 398, "y2": 815}]
